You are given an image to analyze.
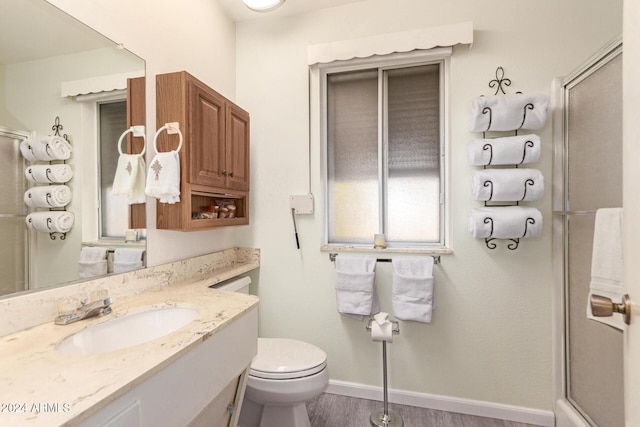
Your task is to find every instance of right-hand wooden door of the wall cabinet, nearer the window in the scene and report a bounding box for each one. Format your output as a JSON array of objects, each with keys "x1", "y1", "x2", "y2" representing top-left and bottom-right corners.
[{"x1": 226, "y1": 104, "x2": 249, "y2": 191}]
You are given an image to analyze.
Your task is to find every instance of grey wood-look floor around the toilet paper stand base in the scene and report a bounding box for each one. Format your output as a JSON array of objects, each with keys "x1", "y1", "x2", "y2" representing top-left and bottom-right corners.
[{"x1": 307, "y1": 393, "x2": 534, "y2": 427}]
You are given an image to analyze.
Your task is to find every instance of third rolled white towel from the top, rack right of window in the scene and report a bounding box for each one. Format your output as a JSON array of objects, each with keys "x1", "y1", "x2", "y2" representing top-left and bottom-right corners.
[{"x1": 472, "y1": 168, "x2": 544, "y2": 202}]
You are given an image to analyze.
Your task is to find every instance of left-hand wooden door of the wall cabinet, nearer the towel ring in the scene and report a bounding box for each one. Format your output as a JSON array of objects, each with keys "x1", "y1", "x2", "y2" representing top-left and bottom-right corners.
[{"x1": 189, "y1": 81, "x2": 227, "y2": 187}]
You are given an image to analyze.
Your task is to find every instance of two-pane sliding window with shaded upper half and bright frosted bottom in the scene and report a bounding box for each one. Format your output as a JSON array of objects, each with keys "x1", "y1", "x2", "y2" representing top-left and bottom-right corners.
[{"x1": 321, "y1": 51, "x2": 448, "y2": 248}]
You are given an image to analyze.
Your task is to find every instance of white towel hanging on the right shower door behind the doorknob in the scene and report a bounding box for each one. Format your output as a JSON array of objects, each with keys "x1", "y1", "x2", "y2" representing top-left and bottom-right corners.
[{"x1": 587, "y1": 208, "x2": 624, "y2": 330}]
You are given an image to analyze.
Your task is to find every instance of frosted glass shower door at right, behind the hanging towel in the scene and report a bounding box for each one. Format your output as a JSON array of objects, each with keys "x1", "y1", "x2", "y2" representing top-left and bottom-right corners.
[{"x1": 554, "y1": 44, "x2": 624, "y2": 427}]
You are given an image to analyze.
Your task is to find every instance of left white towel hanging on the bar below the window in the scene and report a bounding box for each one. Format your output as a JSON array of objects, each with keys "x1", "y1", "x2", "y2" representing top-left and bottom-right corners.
[{"x1": 335, "y1": 255, "x2": 380, "y2": 319}]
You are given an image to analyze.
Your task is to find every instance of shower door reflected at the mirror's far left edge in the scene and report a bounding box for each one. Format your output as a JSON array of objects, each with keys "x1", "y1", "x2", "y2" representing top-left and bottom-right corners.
[{"x1": 0, "y1": 126, "x2": 29, "y2": 296}]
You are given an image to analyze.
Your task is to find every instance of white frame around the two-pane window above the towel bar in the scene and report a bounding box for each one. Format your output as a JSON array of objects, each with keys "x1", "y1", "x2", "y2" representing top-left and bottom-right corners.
[{"x1": 314, "y1": 47, "x2": 452, "y2": 253}]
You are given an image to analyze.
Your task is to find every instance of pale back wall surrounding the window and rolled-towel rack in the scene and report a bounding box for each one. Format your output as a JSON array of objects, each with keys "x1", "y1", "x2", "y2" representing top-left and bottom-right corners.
[{"x1": 237, "y1": 0, "x2": 622, "y2": 410}]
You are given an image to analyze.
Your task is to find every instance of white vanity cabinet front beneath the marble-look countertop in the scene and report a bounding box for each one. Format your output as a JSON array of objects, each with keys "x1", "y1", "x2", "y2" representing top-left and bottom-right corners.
[{"x1": 80, "y1": 307, "x2": 258, "y2": 427}]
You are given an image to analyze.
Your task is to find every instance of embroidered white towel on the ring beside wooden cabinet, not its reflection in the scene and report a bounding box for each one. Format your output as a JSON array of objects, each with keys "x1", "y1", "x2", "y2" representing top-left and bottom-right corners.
[{"x1": 145, "y1": 151, "x2": 180, "y2": 204}]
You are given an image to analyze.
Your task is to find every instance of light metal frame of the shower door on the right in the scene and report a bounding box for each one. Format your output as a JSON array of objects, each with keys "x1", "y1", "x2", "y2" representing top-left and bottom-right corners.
[{"x1": 551, "y1": 37, "x2": 622, "y2": 427}]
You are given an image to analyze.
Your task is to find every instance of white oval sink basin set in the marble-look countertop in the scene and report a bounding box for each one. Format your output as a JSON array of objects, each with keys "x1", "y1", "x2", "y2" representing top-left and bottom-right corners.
[{"x1": 56, "y1": 307, "x2": 198, "y2": 355}]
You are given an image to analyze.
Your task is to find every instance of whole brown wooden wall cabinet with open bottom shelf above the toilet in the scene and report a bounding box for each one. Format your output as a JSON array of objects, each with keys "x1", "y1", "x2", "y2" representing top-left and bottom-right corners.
[{"x1": 156, "y1": 71, "x2": 249, "y2": 231}]
